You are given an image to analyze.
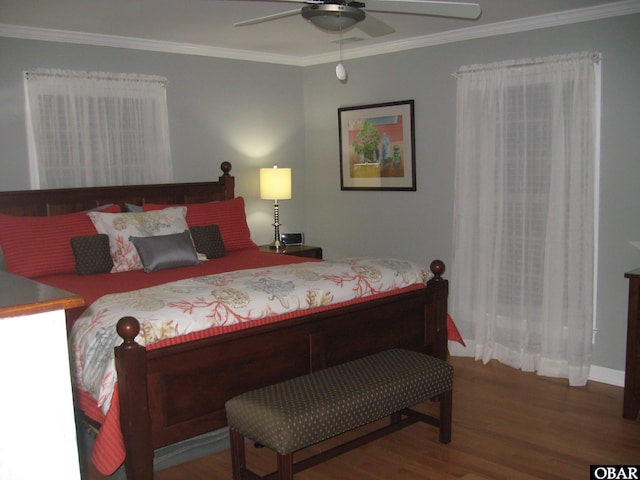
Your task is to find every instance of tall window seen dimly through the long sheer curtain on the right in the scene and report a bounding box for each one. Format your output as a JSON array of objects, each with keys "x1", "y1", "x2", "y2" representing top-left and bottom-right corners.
[{"x1": 498, "y1": 84, "x2": 552, "y2": 313}]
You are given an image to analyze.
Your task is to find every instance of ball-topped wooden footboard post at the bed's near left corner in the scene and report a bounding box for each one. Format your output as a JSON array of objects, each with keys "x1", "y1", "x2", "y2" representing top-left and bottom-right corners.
[{"x1": 115, "y1": 317, "x2": 153, "y2": 480}]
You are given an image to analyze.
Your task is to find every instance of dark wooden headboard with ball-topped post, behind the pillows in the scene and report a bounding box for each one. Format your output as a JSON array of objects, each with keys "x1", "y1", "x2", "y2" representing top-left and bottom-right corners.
[{"x1": 0, "y1": 162, "x2": 235, "y2": 216}]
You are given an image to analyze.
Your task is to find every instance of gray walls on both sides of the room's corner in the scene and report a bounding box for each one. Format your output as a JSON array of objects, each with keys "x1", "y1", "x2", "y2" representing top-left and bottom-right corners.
[{"x1": 0, "y1": 15, "x2": 640, "y2": 370}]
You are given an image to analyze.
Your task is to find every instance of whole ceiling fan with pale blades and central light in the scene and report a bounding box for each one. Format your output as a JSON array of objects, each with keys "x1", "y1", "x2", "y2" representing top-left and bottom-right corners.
[{"x1": 234, "y1": 0, "x2": 482, "y2": 37}]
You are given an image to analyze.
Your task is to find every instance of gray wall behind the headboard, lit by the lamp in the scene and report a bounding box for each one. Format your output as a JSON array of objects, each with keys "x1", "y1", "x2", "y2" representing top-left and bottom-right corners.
[{"x1": 0, "y1": 37, "x2": 304, "y2": 243}]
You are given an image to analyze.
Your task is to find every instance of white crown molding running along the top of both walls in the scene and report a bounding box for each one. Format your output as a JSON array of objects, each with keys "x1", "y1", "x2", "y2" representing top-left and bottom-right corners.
[{"x1": 0, "y1": 0, "x2": 640, "y2": 67}]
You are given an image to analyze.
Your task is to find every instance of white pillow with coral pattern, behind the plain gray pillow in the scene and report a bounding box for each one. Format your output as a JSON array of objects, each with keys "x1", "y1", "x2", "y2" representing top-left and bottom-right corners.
[{"x1": 88, "y1": 207, "x2": 188, "y2": 272}]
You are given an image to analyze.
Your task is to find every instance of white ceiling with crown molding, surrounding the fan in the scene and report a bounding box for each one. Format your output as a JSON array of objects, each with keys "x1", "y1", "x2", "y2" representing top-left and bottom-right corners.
[{"x1": 0, "y1": 0, "x2": 640, "y2": 66}]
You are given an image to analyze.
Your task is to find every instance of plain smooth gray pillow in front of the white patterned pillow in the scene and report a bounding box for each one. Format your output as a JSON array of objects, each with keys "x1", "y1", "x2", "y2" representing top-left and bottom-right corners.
[{"x1": 129, "y1": 230, "x2": 202, "y2": 272}]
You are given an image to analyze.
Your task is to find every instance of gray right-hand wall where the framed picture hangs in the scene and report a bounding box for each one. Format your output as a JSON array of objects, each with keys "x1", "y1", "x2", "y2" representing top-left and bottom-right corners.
[{"x1": 304, "y1": 15, "x2": 640, "y2": 370}]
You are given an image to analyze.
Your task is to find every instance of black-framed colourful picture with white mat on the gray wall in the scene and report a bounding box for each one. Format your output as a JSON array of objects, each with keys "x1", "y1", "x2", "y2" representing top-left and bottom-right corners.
[{"x1": 338, "y1": 100, "x2": 416, "y2": 191}]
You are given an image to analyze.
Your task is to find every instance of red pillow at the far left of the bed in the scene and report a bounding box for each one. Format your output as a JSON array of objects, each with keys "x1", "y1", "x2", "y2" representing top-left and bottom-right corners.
[{"x1": 0, "y1": 205, "x2": 120, "y2": 278}]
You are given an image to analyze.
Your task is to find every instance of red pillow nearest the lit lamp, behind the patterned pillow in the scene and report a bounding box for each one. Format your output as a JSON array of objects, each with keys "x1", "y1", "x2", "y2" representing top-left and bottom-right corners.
[{"x1": 142, "y1": 197, "x2": 258, "y2": 251}]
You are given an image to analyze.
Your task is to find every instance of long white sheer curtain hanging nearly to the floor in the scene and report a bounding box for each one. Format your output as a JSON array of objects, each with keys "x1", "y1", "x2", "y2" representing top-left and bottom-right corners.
[{"x1": 450, "y1": 53, "x2": 600, "y2": 385}]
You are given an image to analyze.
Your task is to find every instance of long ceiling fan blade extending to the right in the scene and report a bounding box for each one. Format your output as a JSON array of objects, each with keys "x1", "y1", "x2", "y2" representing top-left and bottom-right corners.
[{"x1": 365, "y1": 0, "x2": 482, "y2": 20}]
